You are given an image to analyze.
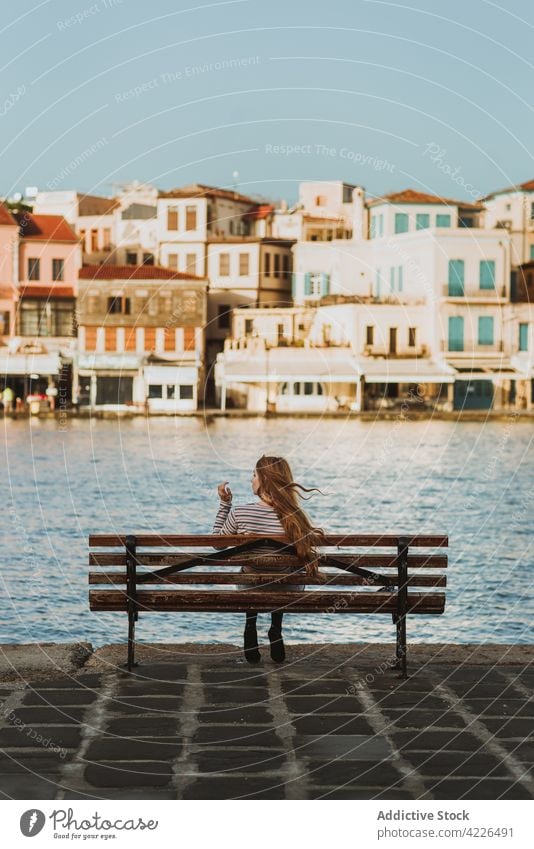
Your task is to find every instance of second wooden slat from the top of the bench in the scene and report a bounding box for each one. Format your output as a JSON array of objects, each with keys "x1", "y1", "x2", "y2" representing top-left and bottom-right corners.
[{"x1": 89, "y1": 551, "x2": 447, "y2": 569}]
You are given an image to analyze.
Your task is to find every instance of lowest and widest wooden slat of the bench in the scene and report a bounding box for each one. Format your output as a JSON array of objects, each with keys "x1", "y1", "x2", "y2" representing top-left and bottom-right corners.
[{"x1": 89, "y1": 590, "x2": 445, "y2": 614}]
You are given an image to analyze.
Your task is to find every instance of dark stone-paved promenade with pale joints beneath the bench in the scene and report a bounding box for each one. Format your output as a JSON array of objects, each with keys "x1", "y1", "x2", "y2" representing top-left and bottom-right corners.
[{"x1": 0, "y1": 646, "x2": 534, "y2": 800}]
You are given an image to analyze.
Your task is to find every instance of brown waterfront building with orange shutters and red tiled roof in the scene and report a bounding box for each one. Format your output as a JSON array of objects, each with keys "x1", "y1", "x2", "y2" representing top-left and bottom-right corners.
[{"x1": 75, "y1": 264, "x2": 207, "y2": 413}]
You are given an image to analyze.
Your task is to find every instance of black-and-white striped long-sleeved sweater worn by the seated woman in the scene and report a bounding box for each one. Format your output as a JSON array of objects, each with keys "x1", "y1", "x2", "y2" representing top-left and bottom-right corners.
[{"x1": 213, "y1": 500, "x2": 296, "y2": 572}]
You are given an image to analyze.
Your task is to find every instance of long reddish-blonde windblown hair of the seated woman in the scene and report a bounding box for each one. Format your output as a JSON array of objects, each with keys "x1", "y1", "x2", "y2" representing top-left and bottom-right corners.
[{"x1": 256, "y1": 455, "x2": 325, "y2": 578}]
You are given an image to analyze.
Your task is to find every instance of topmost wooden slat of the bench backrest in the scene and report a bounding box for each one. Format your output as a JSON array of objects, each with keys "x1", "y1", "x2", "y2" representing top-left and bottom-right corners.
[{"x1": 89, "y1": 534, "x2": 449, "y2": 548}]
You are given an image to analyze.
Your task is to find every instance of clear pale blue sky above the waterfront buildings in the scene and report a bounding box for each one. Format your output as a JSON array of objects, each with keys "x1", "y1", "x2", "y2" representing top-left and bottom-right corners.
[{"x1": 0, "y1": 0, "x2": 534, "y2": 200}]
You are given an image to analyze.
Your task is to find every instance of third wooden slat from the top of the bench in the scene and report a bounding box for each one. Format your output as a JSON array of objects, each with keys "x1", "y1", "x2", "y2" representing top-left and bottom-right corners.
[{"x1": 89, "y1": 572, "x2": 447, "y2": 587}]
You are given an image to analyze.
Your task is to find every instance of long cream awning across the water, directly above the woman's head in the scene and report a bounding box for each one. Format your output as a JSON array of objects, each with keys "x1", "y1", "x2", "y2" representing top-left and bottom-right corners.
[{"x1": 216, "y1": 347, "x2": 360, "y2": 383}]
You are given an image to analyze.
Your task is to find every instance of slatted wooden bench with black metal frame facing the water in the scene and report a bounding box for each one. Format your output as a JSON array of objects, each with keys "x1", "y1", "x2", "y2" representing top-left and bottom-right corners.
[{"x1": 89, "y1": 534, "x2": 448, "y2": 677}]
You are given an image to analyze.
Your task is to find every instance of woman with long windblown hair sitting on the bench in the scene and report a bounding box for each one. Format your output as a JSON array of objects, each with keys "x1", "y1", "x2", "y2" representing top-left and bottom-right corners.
[{"x1": 213, "y1": 456, "x2": 324, "y2": 663}]
